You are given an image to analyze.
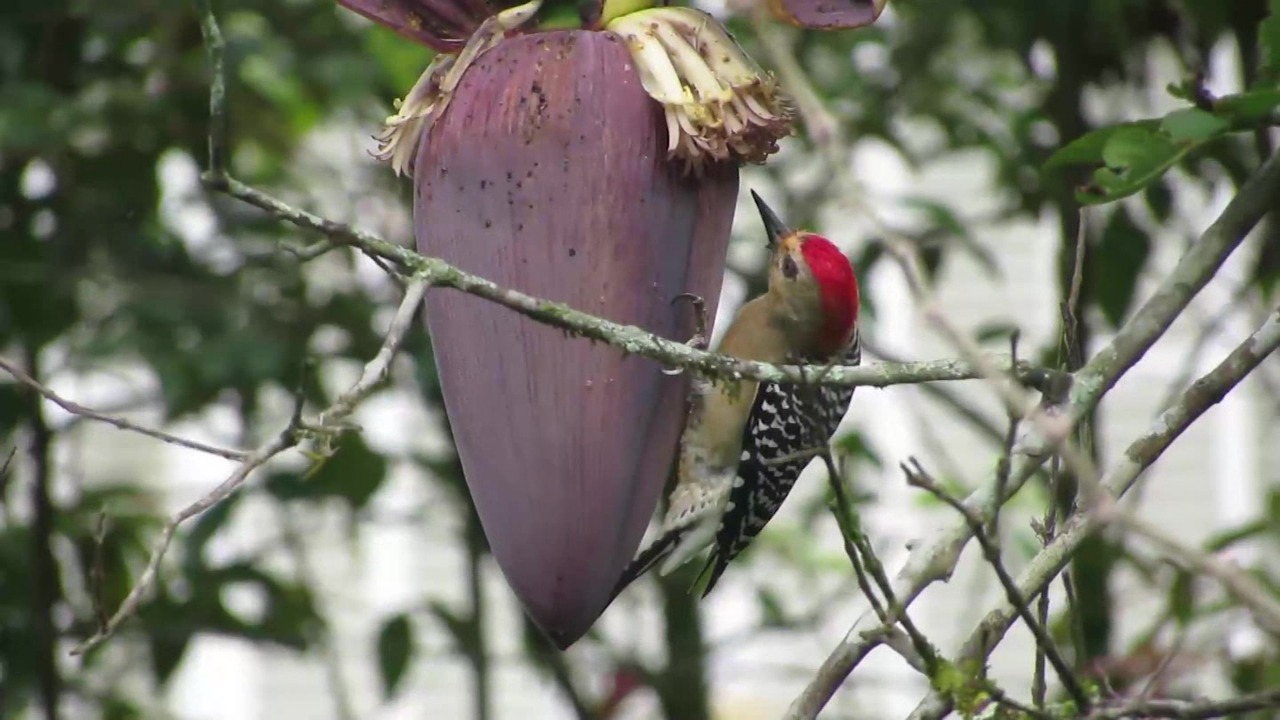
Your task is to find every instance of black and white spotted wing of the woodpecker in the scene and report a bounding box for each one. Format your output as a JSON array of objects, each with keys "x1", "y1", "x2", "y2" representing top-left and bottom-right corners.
[{"x1": 703, "y1": 329, "x2": 861, "y2": 596}]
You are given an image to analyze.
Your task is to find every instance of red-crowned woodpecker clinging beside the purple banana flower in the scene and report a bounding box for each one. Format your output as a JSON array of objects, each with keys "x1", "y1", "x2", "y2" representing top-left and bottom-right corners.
[{"x1": 613, "y1": 191, "x2": 861, "y2": 597}]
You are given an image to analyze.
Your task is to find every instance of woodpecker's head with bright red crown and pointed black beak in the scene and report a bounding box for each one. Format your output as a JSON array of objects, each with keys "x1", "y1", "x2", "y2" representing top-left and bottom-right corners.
[{"x1": 751, "y1": 190, "x2": 858, "y2": 357}]
